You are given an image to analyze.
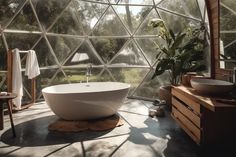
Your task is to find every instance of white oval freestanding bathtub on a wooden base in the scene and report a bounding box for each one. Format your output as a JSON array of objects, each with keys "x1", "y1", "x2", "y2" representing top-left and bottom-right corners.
[{"x1": 42, "y1": 82, "x2": 130, "y2": 120}]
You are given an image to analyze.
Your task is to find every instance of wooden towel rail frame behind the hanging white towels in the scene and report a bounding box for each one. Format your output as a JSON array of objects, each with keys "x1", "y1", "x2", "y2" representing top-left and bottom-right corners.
[{"x1": 7, "y1": 50, "x2": 36, "y2": 111}]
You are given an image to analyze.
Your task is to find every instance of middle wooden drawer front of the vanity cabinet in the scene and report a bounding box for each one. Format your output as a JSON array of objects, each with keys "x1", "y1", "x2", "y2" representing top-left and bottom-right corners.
[{"x1": 172, "y1": 97, "x2": 201, "y2": 128}]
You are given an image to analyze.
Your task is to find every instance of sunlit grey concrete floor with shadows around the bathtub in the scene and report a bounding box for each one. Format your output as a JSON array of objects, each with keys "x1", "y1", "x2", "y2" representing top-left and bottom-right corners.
[{"x1": 0, "y1": 99, "x2": 229, "y2": 157}]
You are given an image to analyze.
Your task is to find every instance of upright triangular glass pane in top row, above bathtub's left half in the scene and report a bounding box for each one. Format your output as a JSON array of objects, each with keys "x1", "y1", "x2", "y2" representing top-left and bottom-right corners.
[{"x1": 49, "y1": 3, "x2": 84, "y2": 35}]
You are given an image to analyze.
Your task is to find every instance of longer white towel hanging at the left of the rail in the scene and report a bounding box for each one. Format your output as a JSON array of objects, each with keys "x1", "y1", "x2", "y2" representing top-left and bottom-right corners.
[{"x1": 12, "y1": 49, "x2": 23, "y2": 109}]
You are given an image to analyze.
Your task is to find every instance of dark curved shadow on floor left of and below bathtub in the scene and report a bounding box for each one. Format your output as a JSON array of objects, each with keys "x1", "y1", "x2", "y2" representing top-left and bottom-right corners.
[{"x1": 1, "y1": 115, "x2": 117, "y2": 147}]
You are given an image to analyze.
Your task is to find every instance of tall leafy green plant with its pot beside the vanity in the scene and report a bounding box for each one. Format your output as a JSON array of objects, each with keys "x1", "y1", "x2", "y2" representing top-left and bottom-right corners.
[{"x1": 150, "y1": 19, "x2": 206, "y2": 108}]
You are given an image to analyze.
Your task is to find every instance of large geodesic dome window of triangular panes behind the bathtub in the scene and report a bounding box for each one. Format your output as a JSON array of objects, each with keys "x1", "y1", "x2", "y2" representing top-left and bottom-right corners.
[{"x1": 0, "y1": 0, "x2": 209, "y2": 99}]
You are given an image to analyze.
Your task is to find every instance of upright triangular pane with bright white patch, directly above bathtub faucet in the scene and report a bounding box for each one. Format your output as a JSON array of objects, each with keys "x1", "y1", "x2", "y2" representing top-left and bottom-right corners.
[{"x1": 65, "y1": 41, "x2": 101, "y2": 66}]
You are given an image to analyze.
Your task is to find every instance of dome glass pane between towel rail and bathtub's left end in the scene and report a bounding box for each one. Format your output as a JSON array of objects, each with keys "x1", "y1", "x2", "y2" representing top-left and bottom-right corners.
[{"x1": 36, "y1": 68, "x2": 58, "y2": 98}]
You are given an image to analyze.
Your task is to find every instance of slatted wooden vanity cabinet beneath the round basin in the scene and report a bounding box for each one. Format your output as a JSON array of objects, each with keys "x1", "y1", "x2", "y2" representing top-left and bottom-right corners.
[{"x1": 171, "y1": 86, "x2": 236, "y2": 145}]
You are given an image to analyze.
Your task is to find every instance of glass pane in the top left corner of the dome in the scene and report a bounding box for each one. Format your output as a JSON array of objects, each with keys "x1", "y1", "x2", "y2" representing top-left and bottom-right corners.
[{"x1": 0, "y1": 0, "x2": 25, "y2": 27}]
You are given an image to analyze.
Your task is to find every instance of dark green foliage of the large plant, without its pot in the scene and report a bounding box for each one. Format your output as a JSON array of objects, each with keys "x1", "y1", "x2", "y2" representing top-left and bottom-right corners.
[{"x1": 152, "y1": 19, "x2": 206, "y2": 84}]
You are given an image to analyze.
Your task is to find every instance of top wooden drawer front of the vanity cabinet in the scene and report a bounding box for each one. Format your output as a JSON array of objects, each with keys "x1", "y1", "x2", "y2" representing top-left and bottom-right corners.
[{"x1": 171, "y1": 90, "x2": 201, "y2": 115}]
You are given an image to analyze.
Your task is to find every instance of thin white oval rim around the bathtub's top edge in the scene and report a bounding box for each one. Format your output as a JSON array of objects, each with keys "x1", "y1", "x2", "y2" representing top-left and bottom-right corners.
[{"x1": 41, "y1": 82, "x2": 131, "y2": 94}]
